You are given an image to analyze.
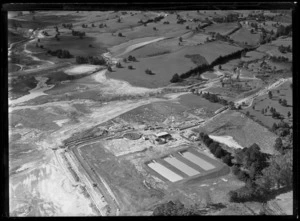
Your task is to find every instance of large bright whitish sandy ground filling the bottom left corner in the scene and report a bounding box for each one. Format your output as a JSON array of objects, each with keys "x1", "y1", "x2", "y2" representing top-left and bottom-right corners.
[{"x1": 9, "y1": 152, "x2": 97, "y2": 216}]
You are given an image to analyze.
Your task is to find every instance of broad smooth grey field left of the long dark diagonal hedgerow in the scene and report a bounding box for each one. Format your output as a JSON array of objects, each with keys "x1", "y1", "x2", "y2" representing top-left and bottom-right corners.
[{"x1": 108, "y1": 42, "x2": 240, "y2": 88}]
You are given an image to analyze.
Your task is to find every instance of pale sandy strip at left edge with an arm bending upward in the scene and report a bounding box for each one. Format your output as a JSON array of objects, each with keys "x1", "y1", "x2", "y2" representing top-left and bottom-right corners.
[{"x1": 8, "y1": 77, "x2": 54, "y2": 106}]
